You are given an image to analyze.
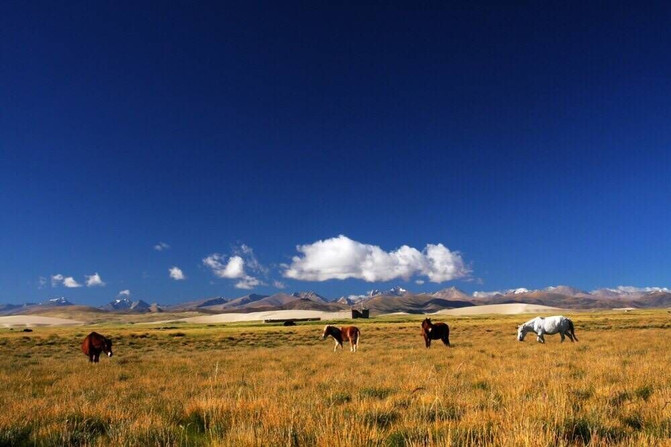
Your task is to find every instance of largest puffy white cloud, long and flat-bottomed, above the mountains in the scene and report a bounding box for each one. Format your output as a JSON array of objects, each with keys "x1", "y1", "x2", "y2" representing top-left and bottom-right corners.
[{"x1": 284, "y1": 235, "x2": 470, "y2": 283}]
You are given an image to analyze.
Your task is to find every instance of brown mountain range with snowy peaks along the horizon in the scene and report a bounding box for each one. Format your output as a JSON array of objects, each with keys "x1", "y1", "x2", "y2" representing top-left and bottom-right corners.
[{"x1": 0, "y1": 286, "x2": 671, "y2": 315}]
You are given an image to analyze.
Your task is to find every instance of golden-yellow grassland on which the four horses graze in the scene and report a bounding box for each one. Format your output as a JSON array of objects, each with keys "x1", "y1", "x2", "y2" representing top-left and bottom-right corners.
[{"x1": 0, "y1": 311, "x2": 671, "y2": 446}]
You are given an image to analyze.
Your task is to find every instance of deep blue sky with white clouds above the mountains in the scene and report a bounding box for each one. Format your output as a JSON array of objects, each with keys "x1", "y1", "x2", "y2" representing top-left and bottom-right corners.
[{"x1": 0, "y1": 2, "x2": 671, "y2": 304}]
